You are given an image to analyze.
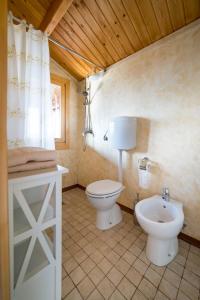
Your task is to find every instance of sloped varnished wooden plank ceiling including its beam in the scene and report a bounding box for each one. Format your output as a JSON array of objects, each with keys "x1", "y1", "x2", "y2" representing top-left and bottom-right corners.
[{"x1": 9, "y1": 0, "x2": 200, "y2": 80}]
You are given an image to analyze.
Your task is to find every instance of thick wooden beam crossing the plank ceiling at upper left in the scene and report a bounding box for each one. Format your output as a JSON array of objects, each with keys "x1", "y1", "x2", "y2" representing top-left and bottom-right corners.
[{"x1": 40, "y1": 0, "x2": 73, "y2": 35}]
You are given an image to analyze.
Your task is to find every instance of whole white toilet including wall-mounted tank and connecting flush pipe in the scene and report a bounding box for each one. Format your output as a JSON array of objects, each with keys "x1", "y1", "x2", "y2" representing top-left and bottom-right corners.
[{"x1": 86, "y1": 116, "x2": 137, "y2": 230}]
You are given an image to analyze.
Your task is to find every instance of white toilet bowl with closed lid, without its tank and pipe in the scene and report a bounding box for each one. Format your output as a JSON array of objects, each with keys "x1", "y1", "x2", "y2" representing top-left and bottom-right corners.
[{"x1": 86, "y1": 179, "x2": 124, "y2": 230}]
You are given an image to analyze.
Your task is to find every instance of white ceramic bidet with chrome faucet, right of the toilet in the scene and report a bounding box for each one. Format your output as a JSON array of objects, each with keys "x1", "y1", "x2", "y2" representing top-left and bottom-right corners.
[{"x1": 135, "y1": 196, "x2": 184, "y2": 266}]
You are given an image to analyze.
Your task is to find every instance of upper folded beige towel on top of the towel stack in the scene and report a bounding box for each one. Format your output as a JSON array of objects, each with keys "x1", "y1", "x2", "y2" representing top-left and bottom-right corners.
[{"x1": 8, "y1": 147, "x2": 56, "y2": 167}]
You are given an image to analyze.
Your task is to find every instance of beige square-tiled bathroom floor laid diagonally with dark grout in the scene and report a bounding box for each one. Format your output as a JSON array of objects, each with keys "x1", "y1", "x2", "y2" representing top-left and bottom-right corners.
[{"x1": 62, "y1": 189, "x2": 200, "y2": 300}]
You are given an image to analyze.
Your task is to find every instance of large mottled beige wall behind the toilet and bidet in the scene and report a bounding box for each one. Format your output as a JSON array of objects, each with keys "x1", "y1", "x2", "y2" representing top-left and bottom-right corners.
[{"x1": 78, "y1": 20, "x2": 200, "y2": 239}]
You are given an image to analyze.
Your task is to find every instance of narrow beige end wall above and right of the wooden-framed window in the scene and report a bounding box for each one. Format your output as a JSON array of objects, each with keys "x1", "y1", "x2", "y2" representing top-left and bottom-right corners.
[{"x1": 50, "y1": 59, "x2": 79, "y2": 187}]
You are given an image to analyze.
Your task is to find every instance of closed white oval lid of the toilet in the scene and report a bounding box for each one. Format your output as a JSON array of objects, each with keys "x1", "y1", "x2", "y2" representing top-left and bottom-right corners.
[{"x1": 86, "y1": 179, "x2": 122, "y2": 195}]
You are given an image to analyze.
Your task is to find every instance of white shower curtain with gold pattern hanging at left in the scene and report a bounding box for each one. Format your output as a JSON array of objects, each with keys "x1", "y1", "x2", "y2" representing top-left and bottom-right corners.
[{"x1": 7, "y1": 13, "x2": 54, "y2": 149}]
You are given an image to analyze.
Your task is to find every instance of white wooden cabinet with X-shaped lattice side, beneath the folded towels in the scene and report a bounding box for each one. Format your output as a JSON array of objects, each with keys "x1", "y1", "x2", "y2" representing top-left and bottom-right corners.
[{"x1": 8, "y1": 166, "x2": 68, "y2": 300}]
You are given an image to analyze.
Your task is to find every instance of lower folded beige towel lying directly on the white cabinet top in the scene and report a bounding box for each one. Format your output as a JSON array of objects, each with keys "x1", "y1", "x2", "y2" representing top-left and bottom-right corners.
[{"x1": 8, "y1": 160, "x2": 56, "y2": 173}]
